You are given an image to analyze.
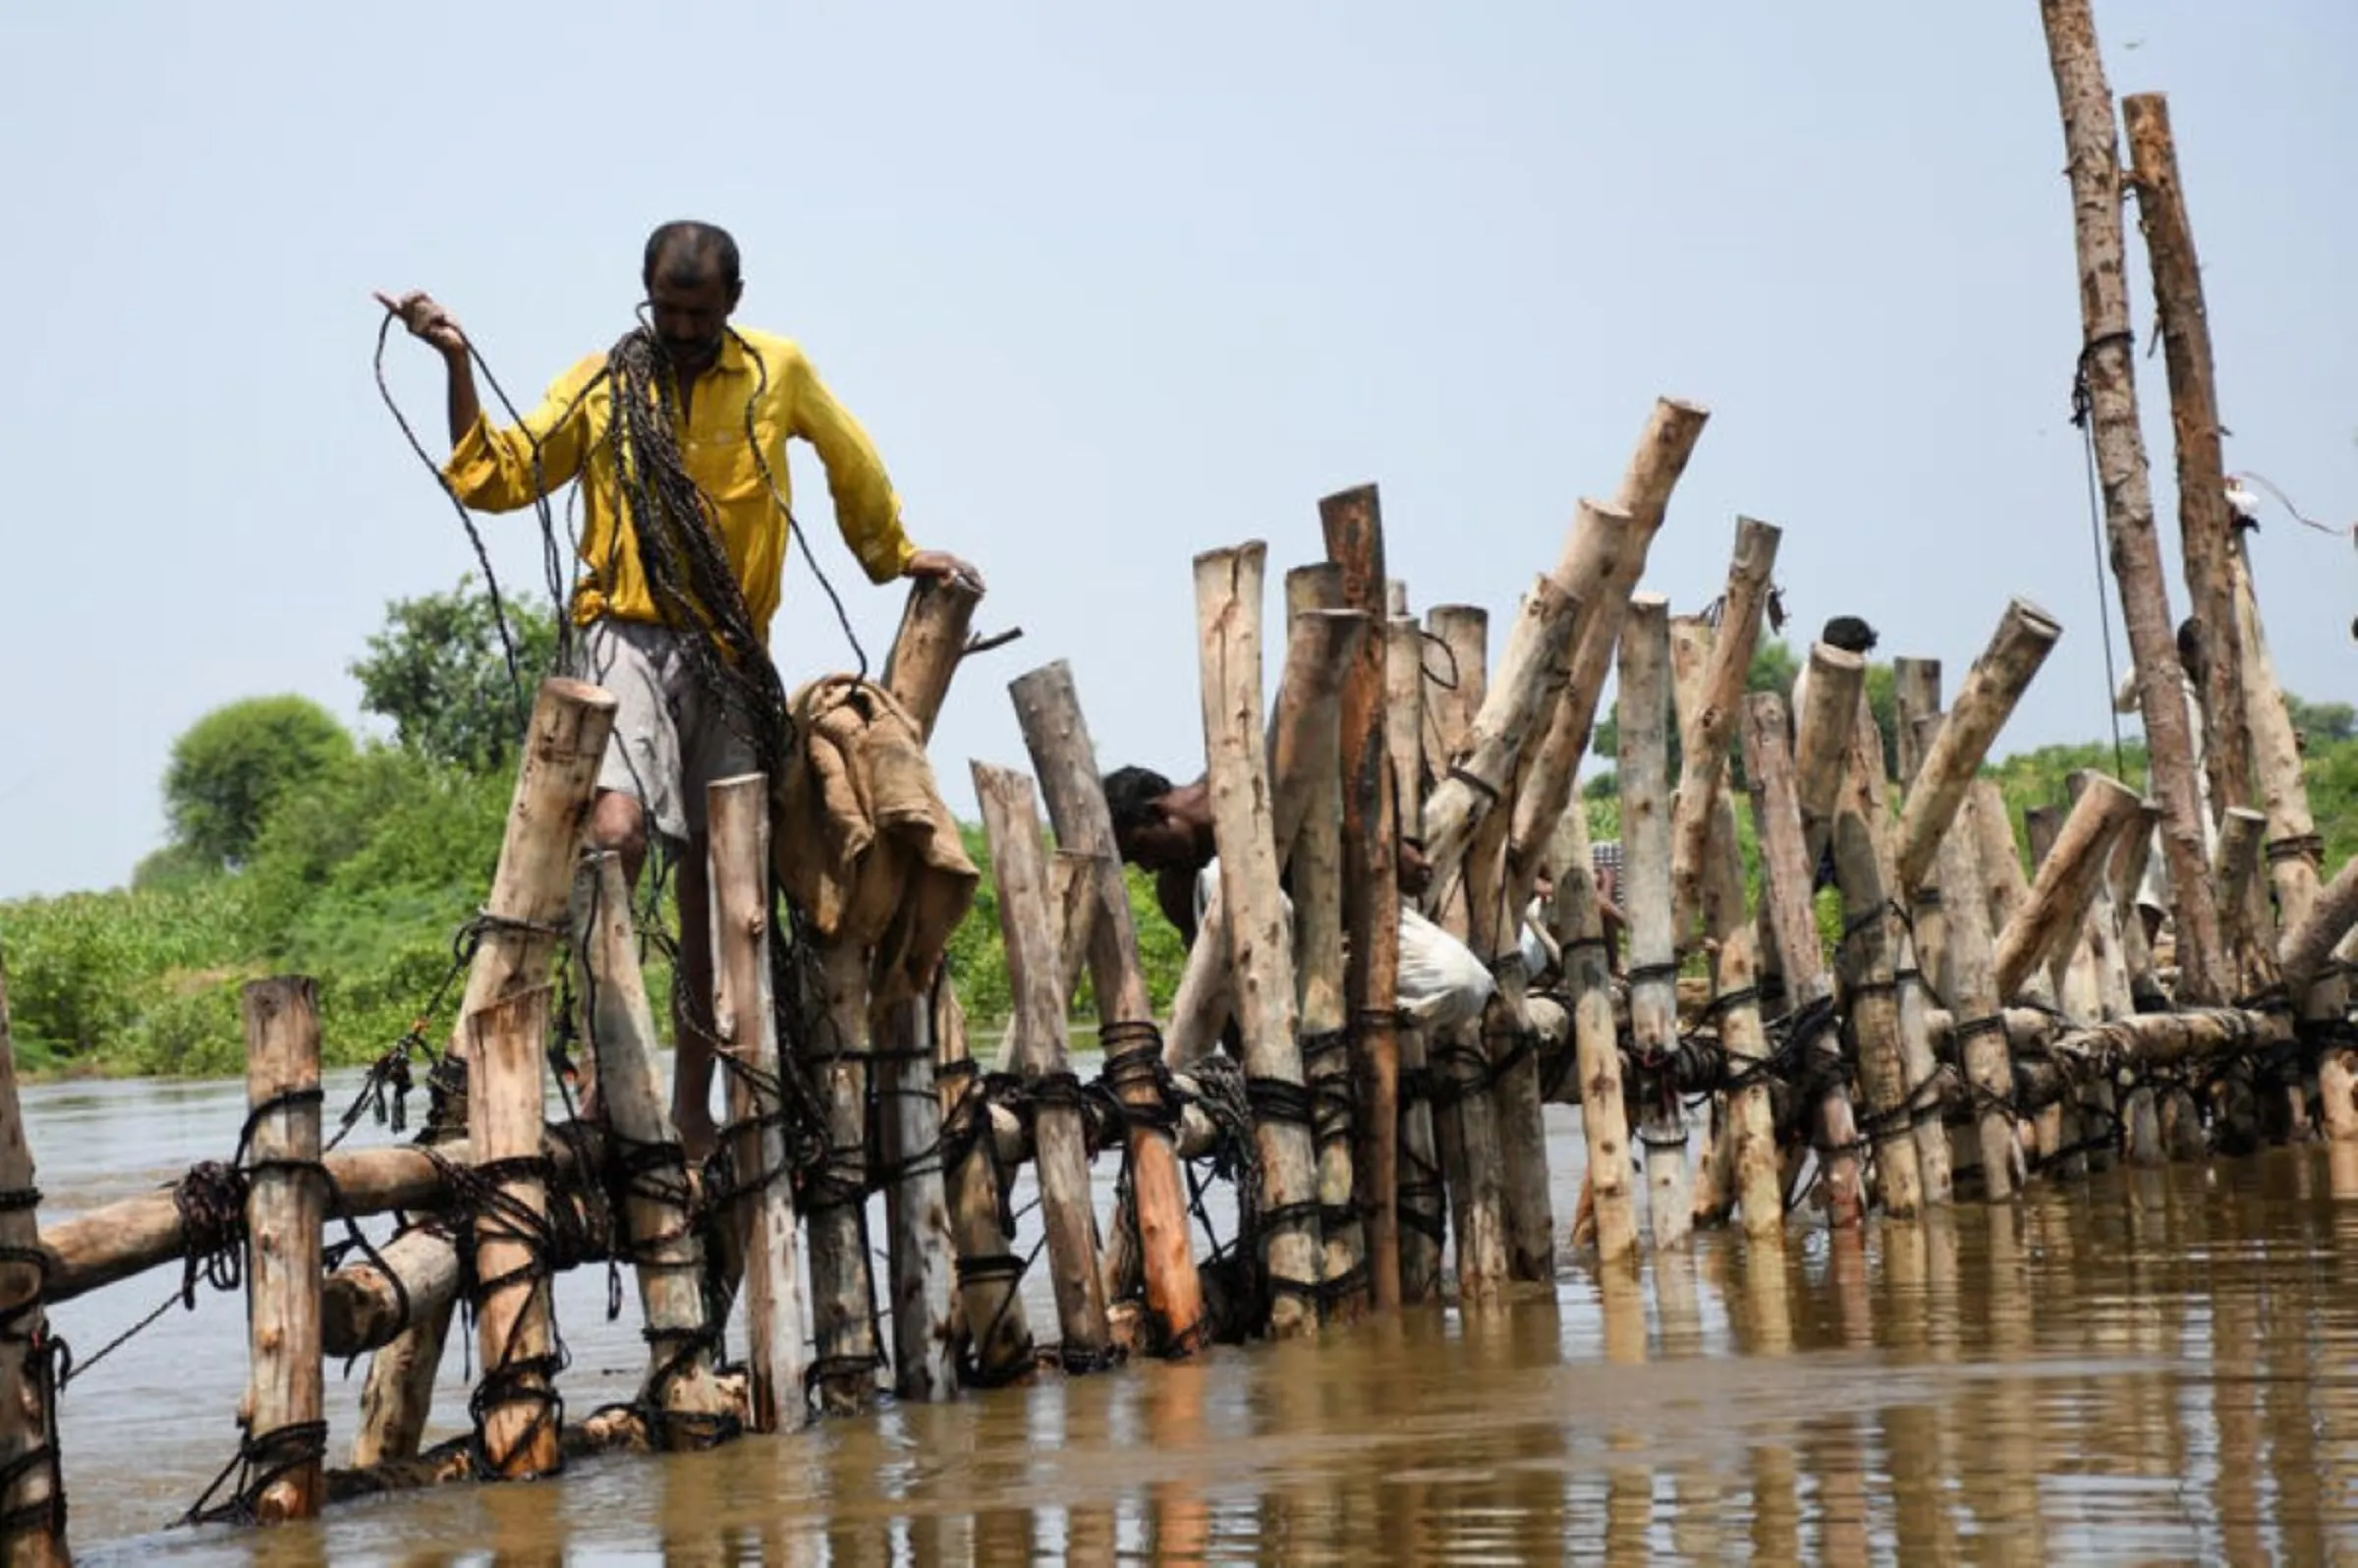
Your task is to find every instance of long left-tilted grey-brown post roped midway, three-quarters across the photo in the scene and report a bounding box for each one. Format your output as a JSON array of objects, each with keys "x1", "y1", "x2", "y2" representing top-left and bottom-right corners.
[{"x1": 1743, "y1": 691, "x2": 1865, "y2": 1231}]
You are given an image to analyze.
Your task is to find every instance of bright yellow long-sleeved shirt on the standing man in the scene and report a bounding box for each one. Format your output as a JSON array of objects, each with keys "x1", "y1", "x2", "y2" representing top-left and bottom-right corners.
[{"x1": 443, "y1": 328, "x2": 918, "y2": 642}]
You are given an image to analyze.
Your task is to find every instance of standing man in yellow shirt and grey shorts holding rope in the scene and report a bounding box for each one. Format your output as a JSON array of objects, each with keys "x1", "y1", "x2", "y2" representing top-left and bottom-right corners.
[{"x1": 377, "y1": 222, "x2": 981, "y2": 1157}]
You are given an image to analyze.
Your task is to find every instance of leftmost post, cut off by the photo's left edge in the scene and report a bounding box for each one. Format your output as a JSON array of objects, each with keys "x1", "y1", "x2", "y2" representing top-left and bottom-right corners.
[{"x1": 0, "y1": 965, "x2": 73, "y2": 1568}]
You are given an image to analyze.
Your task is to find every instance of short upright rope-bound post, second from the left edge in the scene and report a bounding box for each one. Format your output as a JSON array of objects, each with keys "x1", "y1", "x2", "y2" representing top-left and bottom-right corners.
[{"x1": 241, "y1": 977, "x2": 328, "y2": 1523}]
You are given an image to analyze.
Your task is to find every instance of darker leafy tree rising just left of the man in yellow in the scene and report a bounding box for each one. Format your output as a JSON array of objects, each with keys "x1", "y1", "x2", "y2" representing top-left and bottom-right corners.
[{"x1": 349, "y1": 576, "x2": 556, "y2": 773}]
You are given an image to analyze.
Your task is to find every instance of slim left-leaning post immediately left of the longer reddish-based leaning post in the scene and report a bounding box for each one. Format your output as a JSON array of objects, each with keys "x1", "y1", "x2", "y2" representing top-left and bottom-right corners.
[{"x1": 972, "y1": 761, "x2": 1113, "y2": 1372}]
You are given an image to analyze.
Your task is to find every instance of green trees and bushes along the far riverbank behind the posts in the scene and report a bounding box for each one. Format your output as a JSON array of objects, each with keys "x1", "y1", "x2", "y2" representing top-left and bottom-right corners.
[{"x1": 0, "y1": 580, "x2": 2358, "y2": 1075}]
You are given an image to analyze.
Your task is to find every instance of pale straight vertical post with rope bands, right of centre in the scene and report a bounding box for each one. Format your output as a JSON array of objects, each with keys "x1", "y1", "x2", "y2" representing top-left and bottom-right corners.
[{"x1": 1620, "y1": 594, "x2": 1696, "y2": 1252}]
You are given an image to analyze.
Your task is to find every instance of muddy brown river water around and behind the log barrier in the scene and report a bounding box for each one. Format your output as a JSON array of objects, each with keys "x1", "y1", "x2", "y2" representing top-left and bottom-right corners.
[{"x1": 26, "y1": 1063, "x2": 2358, "y2": 1568}]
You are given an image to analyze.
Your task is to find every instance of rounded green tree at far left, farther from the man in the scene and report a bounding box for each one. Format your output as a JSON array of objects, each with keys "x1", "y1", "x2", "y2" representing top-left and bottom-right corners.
[{"x1": 151, "y1": 696, "x2": 352, "y2": 877}]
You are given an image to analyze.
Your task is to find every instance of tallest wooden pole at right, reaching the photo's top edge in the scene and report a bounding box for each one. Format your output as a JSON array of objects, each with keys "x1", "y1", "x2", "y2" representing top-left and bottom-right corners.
[{"x1": 2040, "y1": 0, "x2": 2226, "y2": 1002}]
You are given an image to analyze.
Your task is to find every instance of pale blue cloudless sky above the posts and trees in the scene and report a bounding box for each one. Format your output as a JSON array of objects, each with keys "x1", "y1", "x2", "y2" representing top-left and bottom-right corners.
[{"x1": 0, "y1": 0, "x2": 2358, "y2": 896}]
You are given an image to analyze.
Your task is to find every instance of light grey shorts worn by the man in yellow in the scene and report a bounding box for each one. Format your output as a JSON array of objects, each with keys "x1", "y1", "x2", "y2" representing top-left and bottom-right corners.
[{"x1": 568, "y1": 620, "x2": 759, "y2": 849}]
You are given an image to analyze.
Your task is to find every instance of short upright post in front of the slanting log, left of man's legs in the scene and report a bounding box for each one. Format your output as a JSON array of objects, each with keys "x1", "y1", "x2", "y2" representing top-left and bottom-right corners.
[{"x1": 467, "y1": 985, "x2": 564, "y2": 1481}]
